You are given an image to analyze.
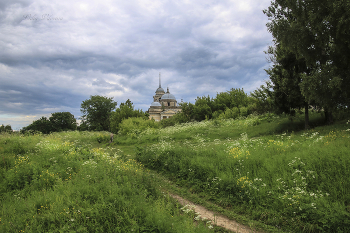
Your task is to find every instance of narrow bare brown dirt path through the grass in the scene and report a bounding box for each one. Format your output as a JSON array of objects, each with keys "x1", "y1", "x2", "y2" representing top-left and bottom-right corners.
[{"x1": 168, "y1": 193, "x2": 259, "y2": 233}]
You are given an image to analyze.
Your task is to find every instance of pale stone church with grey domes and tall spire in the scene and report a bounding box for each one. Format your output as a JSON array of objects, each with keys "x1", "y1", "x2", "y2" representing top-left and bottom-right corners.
[{"x1": 148, "y1": 74, "x2": 181, "y2": 121}]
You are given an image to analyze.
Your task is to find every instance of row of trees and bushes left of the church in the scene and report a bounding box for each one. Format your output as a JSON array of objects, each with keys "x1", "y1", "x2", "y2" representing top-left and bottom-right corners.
[{"x1": 17, "y1": 95, "x2": 152, "y2": 134}]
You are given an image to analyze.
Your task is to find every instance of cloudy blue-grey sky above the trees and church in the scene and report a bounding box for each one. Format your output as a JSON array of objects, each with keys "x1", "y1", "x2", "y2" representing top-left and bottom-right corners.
[{"x1": 0, "y1": 0, "x2": 272, "y2": 130}]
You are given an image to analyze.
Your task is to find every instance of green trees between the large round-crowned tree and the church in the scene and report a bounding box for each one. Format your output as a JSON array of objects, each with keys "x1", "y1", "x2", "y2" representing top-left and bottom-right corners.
[{"x1": 110, "y1": 99, "x2": 148, "y2": 133}]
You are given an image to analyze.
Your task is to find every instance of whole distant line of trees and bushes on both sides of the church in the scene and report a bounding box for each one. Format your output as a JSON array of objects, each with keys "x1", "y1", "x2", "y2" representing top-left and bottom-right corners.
[{"x1": 13, "y1": 82, "x2": 349, "y2": 135}]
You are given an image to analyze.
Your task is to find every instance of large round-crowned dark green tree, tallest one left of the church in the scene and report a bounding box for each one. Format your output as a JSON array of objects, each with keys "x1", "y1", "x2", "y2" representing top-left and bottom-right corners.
[{"x1": 80, "y1": 95, "x2": 117, "y2": 131}]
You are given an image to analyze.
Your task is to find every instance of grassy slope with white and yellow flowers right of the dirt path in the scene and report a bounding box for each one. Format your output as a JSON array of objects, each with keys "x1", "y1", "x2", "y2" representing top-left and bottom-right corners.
[{"x1": 137, "y1": 113, "x2": 350, "y2": 232}]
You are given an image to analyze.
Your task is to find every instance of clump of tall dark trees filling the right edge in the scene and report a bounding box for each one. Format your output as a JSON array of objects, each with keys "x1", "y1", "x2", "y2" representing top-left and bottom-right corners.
[{"x1": 264, "y1": 0, "x2": 350, "y2": 127}]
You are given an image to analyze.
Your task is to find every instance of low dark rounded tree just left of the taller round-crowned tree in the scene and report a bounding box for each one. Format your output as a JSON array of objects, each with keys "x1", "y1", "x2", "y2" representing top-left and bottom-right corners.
[{"x1": 49, "y1": 112, "x2": 77, "y2": 132}]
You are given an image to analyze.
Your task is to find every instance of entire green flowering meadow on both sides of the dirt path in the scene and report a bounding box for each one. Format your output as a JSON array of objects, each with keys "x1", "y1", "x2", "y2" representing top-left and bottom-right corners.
[{"x1": 0, "y1": 114, "x2": 350, "y2": 232}]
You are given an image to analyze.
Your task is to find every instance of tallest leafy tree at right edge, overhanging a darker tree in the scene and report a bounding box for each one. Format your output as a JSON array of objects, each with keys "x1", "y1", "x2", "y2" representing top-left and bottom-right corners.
[{"x1": 264, "y1": 0, "x2": 350, "y2": 123}]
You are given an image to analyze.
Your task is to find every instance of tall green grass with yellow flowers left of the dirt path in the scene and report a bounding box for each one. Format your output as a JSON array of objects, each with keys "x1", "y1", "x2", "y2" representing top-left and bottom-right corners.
[{"x1": 0, "y1": 132, "x2": 209, "y2": 232}]
